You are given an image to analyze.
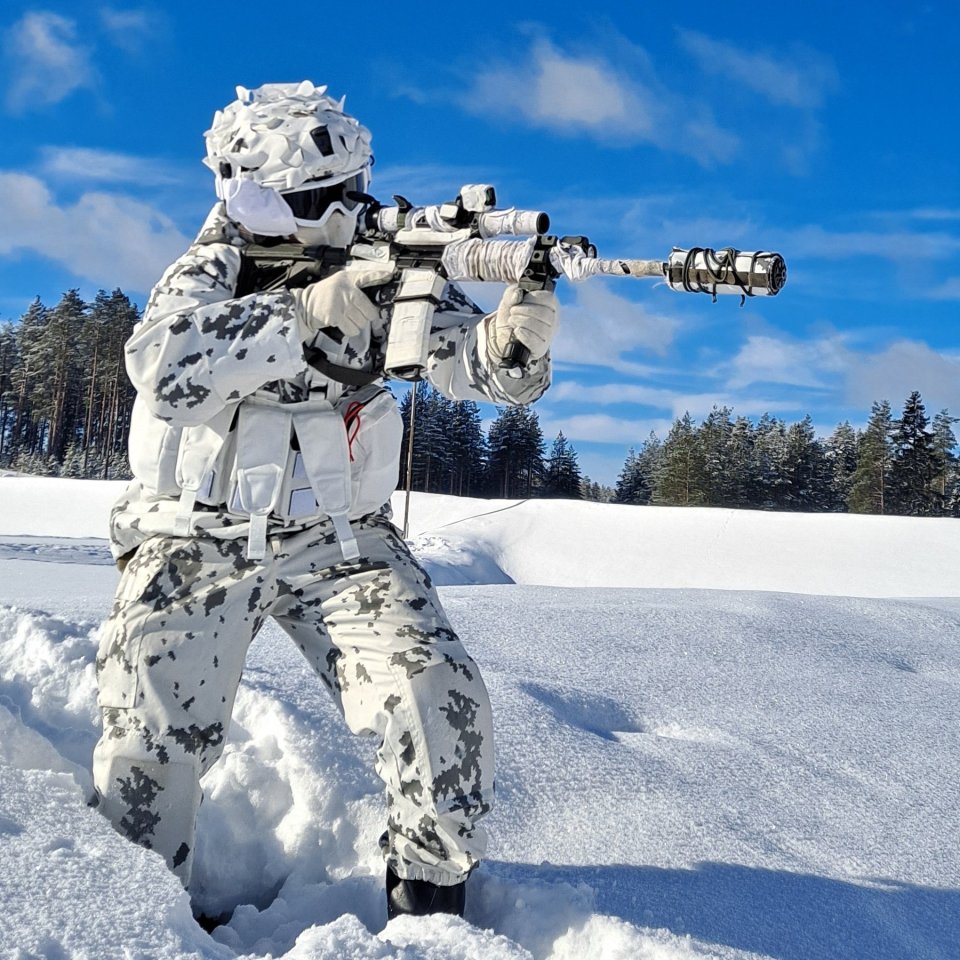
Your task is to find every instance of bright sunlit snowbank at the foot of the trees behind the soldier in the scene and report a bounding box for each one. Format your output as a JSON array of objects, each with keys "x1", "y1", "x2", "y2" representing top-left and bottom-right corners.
[{"x1": 0, "y1": 477, "x2": 960, "y2": 597}]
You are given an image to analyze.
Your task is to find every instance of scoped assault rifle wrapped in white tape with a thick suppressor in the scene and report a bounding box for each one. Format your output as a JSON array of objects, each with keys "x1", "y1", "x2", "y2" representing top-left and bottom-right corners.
[{"x1": 241, "y1": 184, "x2": 787, "y2": 380}]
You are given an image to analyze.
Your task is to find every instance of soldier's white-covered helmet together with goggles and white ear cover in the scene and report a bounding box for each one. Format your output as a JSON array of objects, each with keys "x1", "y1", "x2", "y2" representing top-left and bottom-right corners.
[{"x1": 203, "y1": 80, "x2": 373, "y2": 245}]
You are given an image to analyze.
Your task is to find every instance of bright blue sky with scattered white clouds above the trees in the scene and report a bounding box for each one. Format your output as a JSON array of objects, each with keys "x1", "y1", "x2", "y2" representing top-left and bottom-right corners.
[{"x1": 0, "y1": 0, "x2": 960, "y2": 483}]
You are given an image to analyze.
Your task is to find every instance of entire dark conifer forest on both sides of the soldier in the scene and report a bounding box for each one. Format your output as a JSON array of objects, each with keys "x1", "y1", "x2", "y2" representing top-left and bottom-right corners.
[{"x1": 0, "y1": 290, "x2": 960, "y2": 517}]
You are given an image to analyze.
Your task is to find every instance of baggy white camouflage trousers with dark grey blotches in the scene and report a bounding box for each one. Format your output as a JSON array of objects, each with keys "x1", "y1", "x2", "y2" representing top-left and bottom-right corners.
[{"x1": 93, "y1": 521, "x2": 493, "y2": 885}]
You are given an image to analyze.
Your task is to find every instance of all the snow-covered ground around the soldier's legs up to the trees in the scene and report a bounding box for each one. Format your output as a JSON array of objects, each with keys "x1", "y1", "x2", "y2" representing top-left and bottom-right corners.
[{"x1": 0, "y1": 477, "x2": 960, "y2": 960}]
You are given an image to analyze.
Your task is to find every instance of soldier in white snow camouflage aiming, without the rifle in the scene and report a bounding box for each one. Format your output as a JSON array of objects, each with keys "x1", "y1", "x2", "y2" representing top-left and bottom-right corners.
[{"x1": 94, "y1": 81, "x2": 557, "y2": 917}]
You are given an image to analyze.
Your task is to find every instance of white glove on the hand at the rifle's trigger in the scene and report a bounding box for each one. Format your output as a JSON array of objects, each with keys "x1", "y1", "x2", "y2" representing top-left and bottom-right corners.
[{"x1": 290, "y1": 264, "x2": 393, "y2": 343}]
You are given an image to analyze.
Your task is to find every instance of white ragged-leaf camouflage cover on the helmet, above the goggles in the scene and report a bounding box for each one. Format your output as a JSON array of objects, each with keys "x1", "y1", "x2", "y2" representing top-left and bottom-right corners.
[{"x1": 203, "y1": 80, "x2": 373, "y2": 193}]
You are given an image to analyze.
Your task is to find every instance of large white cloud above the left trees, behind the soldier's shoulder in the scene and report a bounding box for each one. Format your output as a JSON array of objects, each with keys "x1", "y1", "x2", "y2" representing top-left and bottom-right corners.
[{"x1": 0, "y1": 173, "x2": 189, "y2": 293}]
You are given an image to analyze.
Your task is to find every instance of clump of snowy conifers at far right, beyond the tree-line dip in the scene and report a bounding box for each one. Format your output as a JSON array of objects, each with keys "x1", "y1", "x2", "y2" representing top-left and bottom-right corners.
[{"x1": 613, "y1": 391, "x2": 960, "y2": 517}]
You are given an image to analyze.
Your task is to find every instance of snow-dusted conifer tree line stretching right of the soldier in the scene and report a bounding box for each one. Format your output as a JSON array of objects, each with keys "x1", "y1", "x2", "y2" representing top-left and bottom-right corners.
[{"x1": 401, "y1": 386, "x2": 960, "y2": 517}]
